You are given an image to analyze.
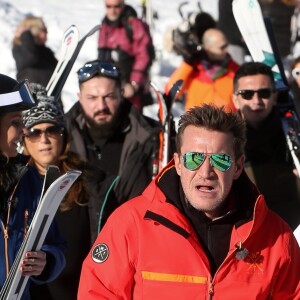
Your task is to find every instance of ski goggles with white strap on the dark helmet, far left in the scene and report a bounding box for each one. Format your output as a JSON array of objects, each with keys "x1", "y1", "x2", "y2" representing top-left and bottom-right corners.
[{"x1": 0, "y1": 81, "x2": 36, "y2": 112}]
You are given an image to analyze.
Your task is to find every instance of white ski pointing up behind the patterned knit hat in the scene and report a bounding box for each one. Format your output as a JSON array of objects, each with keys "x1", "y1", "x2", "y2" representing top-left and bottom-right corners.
[{"x1": 46, "y1": 25, "x2": 79, "y2": 96}]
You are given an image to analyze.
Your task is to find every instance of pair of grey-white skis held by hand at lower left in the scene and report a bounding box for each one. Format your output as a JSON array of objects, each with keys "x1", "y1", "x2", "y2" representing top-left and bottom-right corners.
[{"x1": 0, "y1": 166, "x2": 81, "y2": 300}]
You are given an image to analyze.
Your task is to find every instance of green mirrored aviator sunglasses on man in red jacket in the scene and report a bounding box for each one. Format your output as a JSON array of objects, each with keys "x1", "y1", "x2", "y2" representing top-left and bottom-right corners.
[{"x1": 182, "y1": 152, "x2": 232, "y2": 172}]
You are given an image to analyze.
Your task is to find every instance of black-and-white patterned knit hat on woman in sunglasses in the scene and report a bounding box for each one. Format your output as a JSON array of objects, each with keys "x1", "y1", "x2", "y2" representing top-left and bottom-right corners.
[{"x1": 23, "y1": 83, "x2": 64, "y2": 128}]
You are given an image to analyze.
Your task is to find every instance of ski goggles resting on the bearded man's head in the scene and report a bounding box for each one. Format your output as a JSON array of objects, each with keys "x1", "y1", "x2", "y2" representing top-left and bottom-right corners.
[{"x1": 77, "y1": 61, "x2": 120, "y2": 83}]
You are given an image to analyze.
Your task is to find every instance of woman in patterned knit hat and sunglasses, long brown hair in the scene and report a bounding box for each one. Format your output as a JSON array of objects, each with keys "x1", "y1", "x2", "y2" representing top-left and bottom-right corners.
[{"x1": 23, "y1": 84, "x2": 90, "y2": 300}]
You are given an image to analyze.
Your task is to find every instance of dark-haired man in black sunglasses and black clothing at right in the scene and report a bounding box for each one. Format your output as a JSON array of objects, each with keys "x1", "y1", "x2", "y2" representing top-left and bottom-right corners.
[{"x1": 233, "y1": 62, "x2": 300, "y2": 229}]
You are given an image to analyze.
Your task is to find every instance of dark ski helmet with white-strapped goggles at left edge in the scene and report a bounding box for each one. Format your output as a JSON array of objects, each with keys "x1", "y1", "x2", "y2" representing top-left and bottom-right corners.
[{"x1": 0, "y1": 74, "x2": 36, "y2": 114}]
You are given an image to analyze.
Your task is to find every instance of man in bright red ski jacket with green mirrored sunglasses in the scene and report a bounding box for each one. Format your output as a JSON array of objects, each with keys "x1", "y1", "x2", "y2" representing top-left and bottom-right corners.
[{"x1": 78, "y1": 105, "x2": 300, "y2": 300}]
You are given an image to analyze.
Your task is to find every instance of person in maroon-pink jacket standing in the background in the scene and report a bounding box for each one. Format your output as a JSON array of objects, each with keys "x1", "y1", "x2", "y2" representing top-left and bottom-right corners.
[{"x1": 98, "y1": 0, "x2": 154, "y2": 109}]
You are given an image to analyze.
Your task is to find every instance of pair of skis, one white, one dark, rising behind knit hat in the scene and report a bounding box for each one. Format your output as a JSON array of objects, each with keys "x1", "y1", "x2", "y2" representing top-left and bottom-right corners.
[{"x1": 46, "y1": 24, "x2": 101, "y2": 99}]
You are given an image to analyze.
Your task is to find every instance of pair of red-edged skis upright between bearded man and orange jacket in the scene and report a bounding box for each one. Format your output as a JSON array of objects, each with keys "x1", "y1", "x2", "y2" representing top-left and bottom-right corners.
[{"x1": 150, "y1": 79, "x2": 183, "y2": 172}]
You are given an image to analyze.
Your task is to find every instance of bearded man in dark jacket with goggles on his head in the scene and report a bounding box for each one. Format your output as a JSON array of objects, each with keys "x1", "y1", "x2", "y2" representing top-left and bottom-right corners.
[{"x1": 66, "y1": 60, "x2": 158, "y2": 242}]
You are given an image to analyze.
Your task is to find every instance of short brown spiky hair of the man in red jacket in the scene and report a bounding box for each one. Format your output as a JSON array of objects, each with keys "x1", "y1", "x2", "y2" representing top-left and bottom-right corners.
[{"x1": 176, "y1": 104, "x2": 246, "y2": 159}]
